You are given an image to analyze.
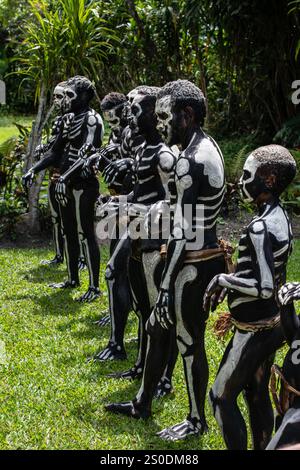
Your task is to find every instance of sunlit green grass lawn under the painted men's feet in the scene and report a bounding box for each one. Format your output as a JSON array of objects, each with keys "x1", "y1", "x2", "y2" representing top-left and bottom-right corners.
[{"x1": 0, "y1": 242, "x2": 300, "y2": 450}]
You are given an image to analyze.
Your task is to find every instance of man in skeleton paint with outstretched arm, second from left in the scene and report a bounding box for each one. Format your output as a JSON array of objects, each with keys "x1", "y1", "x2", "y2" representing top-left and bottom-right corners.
[{"x1": 24, "y1": 76, "x2": 103, "y2": 301}]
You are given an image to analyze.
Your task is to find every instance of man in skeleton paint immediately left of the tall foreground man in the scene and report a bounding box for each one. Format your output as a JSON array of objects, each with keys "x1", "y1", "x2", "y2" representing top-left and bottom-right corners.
[{"x1": 99, "y1": 86, "x2": 176, "y2": 396}]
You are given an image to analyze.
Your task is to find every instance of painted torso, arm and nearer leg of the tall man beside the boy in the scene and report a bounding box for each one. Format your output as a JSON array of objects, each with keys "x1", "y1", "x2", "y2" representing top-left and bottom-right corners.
[{"x1": 154, "y1": 137, "x2": 224, "y2": 440}]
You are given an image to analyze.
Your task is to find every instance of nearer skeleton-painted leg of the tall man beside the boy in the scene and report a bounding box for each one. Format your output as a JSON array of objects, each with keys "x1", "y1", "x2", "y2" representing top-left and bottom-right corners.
[{"x1": 158, "y1": 259, "x2": 224, "y2": 441}]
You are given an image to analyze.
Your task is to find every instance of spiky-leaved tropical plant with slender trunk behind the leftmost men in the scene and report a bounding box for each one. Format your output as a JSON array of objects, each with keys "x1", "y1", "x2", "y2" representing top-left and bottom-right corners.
[{"x1": 9, "y1": 0, "x2": 116, "y2": 230}]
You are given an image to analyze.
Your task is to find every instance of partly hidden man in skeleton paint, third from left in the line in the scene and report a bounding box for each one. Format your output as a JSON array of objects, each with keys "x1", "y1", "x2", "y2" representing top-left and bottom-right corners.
[{"x1": 91, "y1": 93, "x2": 144, "y2": 346}]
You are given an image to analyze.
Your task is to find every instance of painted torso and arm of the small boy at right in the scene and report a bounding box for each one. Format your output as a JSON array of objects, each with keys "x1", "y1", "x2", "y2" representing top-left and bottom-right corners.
[{"x1": 205, "y1": 201, "x2": 292, "y2": 322}]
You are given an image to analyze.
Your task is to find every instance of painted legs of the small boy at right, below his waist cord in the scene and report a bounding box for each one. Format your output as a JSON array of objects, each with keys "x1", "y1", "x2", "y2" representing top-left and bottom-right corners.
[{"x1": 209, "y1": 327, "x2": 283, "y2": 450}]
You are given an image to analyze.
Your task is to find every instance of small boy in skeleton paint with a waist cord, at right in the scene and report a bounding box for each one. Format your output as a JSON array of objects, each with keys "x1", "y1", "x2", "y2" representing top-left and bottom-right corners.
[{"x1": 204, "y1": 145, "x2": 296, "y2": 449}]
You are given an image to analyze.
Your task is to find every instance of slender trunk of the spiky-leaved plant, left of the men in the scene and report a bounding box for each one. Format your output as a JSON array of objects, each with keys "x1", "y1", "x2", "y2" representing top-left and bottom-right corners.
[{"x1": 25, "y1": 83, "x2": 47, "y2": 233}]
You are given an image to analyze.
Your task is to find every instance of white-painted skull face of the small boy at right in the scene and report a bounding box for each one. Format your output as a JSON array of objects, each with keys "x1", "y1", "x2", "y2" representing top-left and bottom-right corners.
[{"x1": 239, "y1": 154, "x2": 264, "y2": 202}]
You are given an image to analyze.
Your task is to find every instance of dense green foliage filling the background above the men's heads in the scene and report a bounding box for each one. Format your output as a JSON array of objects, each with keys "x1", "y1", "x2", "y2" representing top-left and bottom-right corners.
[{"x1": 0, "y1": 0, "x2": 300, "y2": 139}]
